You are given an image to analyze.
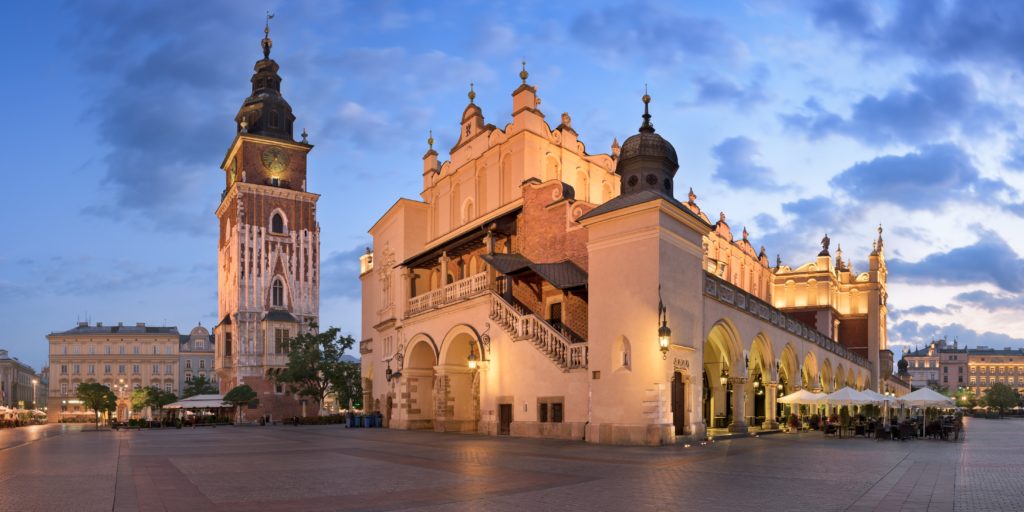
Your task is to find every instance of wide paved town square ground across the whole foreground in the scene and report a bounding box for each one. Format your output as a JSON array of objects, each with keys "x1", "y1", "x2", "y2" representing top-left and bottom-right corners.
[{"x1": 0, "y1": 420, "x2": 1024, "y2": 512}]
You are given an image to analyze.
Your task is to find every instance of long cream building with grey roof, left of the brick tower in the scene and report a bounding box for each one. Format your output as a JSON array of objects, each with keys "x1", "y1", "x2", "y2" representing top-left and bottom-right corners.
[{"x1": 46, "y1": 322, "x2": 181, "y2": 422}]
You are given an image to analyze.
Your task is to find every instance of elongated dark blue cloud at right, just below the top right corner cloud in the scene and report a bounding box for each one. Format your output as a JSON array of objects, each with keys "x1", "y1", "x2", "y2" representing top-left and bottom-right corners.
[{"x1": 781, "y1": 73, "x2": 1006, "y2": 145}]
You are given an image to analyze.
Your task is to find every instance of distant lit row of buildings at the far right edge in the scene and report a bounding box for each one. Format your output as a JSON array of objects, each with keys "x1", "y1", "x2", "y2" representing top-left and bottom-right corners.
[{"x1": 903, "y1": 339, "x2": 1024, "y2": 396}]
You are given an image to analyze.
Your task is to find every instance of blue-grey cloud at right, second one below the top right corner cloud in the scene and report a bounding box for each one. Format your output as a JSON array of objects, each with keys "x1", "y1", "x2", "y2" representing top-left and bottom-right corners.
[{"x1": 829, "y1": 144, "x2": 1016, "y2": 211}]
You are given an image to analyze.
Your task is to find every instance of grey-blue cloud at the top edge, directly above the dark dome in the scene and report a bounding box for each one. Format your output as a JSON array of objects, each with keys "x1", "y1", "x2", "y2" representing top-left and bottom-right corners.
[{"x1": 570, "y1": 1, "x2": 745, "y2": 67}]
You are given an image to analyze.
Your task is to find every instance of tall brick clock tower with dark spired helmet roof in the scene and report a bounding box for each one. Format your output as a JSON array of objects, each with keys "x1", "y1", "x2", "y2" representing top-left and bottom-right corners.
[{"x1": 214, "y1": 19, "x2": 319, "y2": 420}]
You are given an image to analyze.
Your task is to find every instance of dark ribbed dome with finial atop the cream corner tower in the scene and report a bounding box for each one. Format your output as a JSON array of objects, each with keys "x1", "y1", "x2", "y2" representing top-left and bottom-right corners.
[{"x1": 615, "y1": 94, "x2": 679, "y2": 198}]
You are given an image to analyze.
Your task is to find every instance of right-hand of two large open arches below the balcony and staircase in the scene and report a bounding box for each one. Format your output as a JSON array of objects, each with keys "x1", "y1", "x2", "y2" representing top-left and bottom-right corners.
[{"x1": 434, "y1": 326, "x2": 482, "y2": 432}]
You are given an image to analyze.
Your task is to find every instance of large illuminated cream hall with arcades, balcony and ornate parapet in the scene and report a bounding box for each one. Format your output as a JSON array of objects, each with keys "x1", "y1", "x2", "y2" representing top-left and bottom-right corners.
[{"x1": 360, "y1": 70, "x2": 892, "y2": 444}]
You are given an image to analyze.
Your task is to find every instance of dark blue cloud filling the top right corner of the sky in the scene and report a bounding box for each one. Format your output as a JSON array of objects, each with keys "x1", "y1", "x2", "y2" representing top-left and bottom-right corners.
[{"x1": 811, "y1": 0, "x2": 1024, "y2": 68}]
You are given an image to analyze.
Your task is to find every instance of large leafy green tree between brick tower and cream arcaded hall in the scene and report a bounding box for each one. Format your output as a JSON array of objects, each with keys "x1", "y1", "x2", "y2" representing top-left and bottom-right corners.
[{"x1": 276, "y1": 323, "x2": 361, "y2": 407}]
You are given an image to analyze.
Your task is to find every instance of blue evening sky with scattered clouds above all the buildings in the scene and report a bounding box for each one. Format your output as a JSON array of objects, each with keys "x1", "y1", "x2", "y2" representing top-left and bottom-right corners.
[{"x1": 0, "y1": 0, "x2": 1024, "y2": 368}]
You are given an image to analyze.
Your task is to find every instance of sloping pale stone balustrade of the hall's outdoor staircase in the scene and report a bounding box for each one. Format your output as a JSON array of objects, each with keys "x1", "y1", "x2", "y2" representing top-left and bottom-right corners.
[{"x1": 489, "y1": 291, "x2": 589, "y2": 372}]
